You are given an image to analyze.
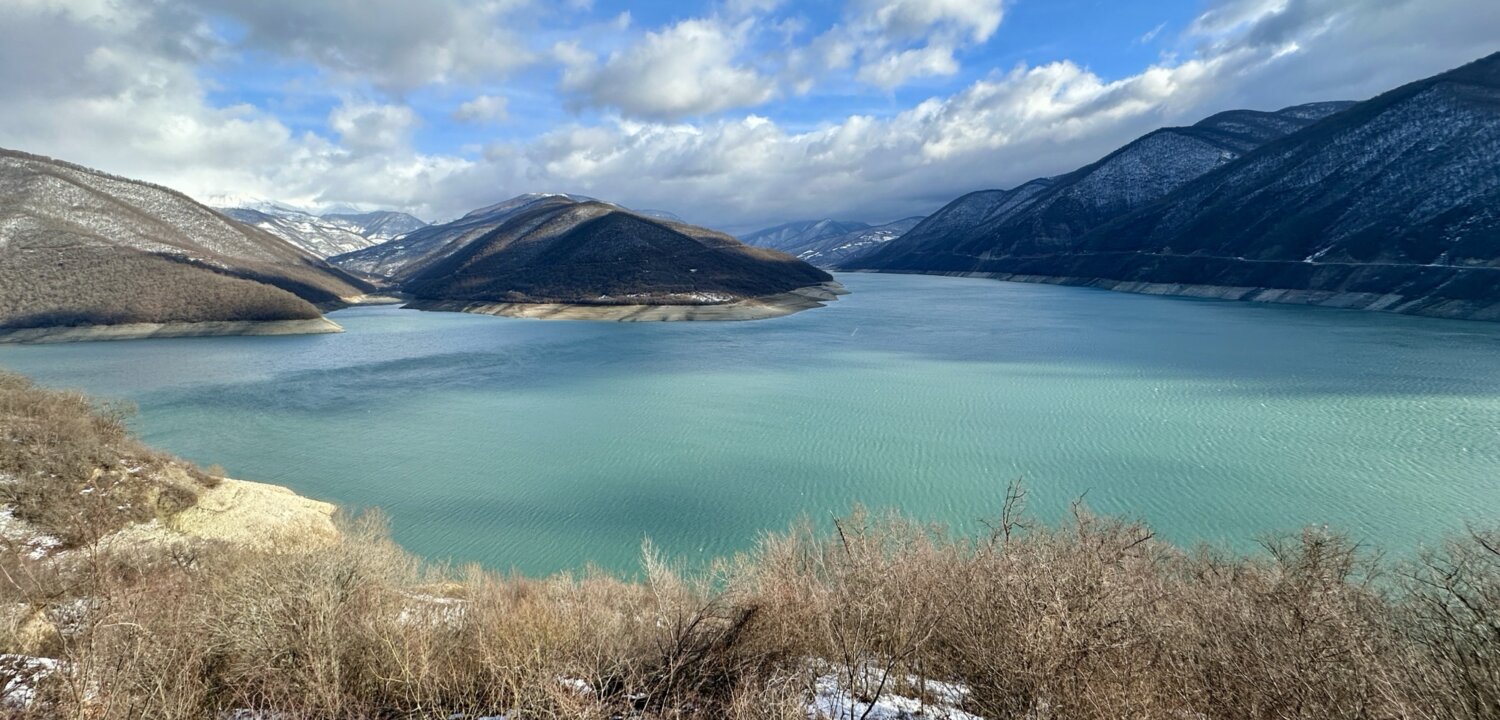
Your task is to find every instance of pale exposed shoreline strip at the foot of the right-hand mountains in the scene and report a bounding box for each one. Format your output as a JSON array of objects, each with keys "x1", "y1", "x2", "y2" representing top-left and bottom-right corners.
[{"x1": 840, "y1": 270, "x2": 1500, "y2": 323}]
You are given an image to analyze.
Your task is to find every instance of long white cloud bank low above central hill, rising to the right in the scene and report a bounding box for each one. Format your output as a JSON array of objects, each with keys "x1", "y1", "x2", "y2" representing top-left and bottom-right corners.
[{"x1": 474, "y1": 56, "x2": 1217, "y2": 230}]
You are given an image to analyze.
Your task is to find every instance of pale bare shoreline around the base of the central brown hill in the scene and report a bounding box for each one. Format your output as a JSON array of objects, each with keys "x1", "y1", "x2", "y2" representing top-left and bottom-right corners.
[{"x1": 407, "y1": 281, "x2": 849, "y2": 323}]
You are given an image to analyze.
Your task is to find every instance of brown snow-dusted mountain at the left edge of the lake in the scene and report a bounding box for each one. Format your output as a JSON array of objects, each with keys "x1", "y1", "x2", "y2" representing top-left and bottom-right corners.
[{"x1": 0, "y1": 150, "x2": 371, "y2": 337}]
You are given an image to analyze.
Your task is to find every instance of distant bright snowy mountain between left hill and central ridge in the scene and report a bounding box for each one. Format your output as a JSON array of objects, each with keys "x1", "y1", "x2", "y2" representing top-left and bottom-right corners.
[{"x1": 219, "y1": 204, "x2": 428, "y2": 258}]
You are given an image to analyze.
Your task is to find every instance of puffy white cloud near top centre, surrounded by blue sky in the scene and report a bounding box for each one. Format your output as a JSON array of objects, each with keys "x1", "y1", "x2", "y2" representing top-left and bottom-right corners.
[{"x1": 554, "y1": 18, "x2": 776, "y2": 119}]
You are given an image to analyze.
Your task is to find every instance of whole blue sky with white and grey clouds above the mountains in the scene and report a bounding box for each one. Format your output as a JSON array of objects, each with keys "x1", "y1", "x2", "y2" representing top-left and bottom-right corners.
[{"x1": 0, "y1": 0, "x2": 1500, "y2": 233}]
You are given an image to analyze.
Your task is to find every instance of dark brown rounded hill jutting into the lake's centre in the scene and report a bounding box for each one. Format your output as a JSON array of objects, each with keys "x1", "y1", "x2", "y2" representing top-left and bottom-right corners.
[{"x1": 402, "y1": 203, "x2": 833, "y2": 305}]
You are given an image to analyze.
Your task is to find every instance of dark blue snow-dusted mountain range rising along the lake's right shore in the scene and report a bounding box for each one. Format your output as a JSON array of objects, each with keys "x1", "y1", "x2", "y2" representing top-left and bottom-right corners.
[{"x1": 857, "y1": 53, "x2": 1500, "y2": 321}]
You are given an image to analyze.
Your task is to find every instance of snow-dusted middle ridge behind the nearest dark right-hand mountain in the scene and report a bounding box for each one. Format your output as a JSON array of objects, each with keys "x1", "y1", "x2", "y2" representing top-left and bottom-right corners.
[{"x1": 846, "y1": 102, "x2": 1353, "y2": 272}]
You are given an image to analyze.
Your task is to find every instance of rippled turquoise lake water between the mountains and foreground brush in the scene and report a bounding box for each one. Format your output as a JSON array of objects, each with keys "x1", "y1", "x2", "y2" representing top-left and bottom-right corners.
[{"x1": 0, "y1": 275, "x2": 1500, "y2": 573}]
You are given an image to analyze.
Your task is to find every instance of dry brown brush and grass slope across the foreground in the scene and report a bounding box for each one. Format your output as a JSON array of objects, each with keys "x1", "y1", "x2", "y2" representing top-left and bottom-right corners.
[{"x1": 0, "y1": 377, "x2": 1500, "y2": 720}]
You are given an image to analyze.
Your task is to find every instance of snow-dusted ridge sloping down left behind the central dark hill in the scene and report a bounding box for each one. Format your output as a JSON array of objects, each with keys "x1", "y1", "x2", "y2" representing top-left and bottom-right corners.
[{"x1": 329, "y1": 192, "x2": 594, "y2": 279}]
